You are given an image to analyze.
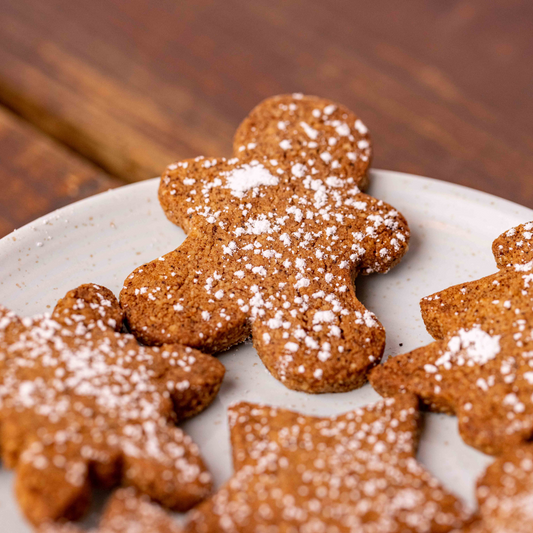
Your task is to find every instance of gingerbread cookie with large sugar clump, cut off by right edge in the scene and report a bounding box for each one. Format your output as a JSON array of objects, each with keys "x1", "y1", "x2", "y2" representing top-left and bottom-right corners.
[{"x1": 370, "y1": 223, "x2": 533, "y2": 454}]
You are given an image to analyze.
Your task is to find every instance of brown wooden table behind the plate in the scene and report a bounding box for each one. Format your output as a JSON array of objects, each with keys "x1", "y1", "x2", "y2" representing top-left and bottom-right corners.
[{"x1": 0, "y1": 0, "x2": 533, "y2": 236}]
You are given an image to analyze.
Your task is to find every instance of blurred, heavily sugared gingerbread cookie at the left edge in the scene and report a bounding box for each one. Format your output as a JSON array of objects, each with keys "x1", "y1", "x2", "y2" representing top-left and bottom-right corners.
[{"x1": 0, "y1": 285, "x2": 224, "y2": 524}]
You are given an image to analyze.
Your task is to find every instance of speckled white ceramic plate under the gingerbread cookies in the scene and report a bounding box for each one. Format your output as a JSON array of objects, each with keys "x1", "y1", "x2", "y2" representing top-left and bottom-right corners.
[{"x1": 0, "y1": 171, "x2": 533, "y2": 533}]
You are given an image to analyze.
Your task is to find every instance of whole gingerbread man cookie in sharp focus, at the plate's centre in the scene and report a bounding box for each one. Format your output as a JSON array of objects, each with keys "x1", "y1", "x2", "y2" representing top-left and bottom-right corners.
[{"x1": 121, "y1": 95, "x2": 409, "y2": 392}]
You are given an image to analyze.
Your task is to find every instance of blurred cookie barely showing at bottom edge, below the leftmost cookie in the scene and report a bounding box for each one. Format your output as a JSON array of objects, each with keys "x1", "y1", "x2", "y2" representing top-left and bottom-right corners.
[{"x1": 37, "y1": 487, "x2": 183, "y2": 533}]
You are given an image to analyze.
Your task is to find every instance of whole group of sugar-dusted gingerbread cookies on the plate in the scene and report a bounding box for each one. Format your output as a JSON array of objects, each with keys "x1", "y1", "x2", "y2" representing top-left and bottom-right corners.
[{"x1": 0, "y1": 94, "x2": 533, "y2": 533}]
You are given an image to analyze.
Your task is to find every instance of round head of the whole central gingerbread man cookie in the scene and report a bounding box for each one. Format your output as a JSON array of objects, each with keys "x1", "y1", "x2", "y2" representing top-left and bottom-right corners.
[{"x1": 233, "y1": 94, "x2": 372, "y2": 190}]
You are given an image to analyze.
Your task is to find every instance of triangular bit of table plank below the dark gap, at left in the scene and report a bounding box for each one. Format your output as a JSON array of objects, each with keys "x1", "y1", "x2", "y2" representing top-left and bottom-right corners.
[{"x1": 0, "y1": 108, "x2": 122, "y2": 237}]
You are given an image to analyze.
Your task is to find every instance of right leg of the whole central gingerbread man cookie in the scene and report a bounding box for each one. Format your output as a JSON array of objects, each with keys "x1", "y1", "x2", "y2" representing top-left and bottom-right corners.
[{"x1": 253, "y1": 283, "x2": 385, "y2": 393}]
